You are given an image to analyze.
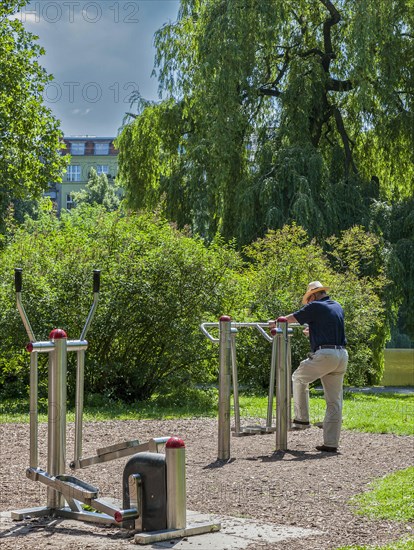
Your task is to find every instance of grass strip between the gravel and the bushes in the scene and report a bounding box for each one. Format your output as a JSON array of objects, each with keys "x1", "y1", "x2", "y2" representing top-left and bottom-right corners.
[{"x1": 0, "y1": 390, "x2": 414, "y2": 435}]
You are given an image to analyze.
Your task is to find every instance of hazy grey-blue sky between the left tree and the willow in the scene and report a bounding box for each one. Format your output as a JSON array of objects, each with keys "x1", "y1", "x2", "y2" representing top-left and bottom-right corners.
[{"x1": 16, "y1": 0, "x2": 179, "y2": 136}]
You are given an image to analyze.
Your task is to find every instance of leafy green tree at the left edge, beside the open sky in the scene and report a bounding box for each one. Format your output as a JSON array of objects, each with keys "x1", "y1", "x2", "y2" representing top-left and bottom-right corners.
[{"x1": 0, "y1": 0, "x2": 65, "y2": 231}]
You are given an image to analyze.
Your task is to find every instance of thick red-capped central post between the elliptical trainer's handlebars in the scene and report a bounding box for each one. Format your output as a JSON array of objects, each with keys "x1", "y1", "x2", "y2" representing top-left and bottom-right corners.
[{"x1": 47, "y1": 329, "x2": 67, "y2": 509}]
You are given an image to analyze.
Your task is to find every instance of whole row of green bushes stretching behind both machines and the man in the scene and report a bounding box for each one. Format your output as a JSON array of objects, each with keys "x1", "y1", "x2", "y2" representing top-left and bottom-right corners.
[{"x1": 0, "y1": 205, "x2": 386, "y2": 401}]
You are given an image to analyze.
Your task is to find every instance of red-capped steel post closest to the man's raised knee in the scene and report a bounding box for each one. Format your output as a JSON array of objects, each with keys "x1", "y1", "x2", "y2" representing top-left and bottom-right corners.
[{"x1": 276, "y1": 317, "x2": 288, "y2": 451}]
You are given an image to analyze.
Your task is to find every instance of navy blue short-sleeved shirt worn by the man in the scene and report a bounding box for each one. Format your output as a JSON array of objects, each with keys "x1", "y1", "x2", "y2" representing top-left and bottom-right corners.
[{"x1": 293, "y1": 296, "x2": 346, "y2": 351}]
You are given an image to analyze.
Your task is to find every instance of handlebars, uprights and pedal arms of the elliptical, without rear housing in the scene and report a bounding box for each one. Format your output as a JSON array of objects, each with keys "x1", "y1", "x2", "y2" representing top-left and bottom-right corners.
[{"x1": 11, "y1": 268, "x2": 168, "y2": 525}]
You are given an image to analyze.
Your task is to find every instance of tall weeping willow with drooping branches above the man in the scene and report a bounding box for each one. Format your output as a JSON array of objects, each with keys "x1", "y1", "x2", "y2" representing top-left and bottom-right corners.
[{"x1": 118, "y1": 0, "x2": 414, "y2": 243}]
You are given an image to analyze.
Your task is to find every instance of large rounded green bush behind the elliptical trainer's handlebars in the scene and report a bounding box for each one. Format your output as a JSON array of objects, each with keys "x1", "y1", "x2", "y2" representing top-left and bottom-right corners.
[{"x1": 0, "y1": 207, "x2": 246, "y2": 400}]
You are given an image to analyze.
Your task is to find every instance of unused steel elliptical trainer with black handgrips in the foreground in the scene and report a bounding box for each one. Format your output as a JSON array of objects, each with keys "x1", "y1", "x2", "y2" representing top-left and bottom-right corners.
[{"x1": 11, "y1": 268, "x2": 220, "y2": 544}]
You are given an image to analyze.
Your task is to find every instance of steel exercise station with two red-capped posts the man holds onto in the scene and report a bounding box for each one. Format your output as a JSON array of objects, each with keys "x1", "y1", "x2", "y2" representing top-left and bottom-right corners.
[{"x1": 200, "y1": 315, "x2": 293, "y2": 460}]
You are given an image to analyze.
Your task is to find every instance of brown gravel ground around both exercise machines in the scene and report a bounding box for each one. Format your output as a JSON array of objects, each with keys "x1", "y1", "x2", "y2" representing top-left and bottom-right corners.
[{"x1": 0, "y1": 419, "x2": 414, "y2": 550}]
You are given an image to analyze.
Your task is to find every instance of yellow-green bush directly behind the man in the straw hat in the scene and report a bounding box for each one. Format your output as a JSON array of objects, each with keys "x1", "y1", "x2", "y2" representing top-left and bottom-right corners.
[{"x1": 234, "y1": 225, "x2": 388, "y2": 386}]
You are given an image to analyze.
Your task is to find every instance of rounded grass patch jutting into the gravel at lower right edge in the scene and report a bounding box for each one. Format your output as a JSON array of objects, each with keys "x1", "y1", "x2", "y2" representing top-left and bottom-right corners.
[{"x1": 351, "y1": 466, "x2": 414, "y2": 521}]
